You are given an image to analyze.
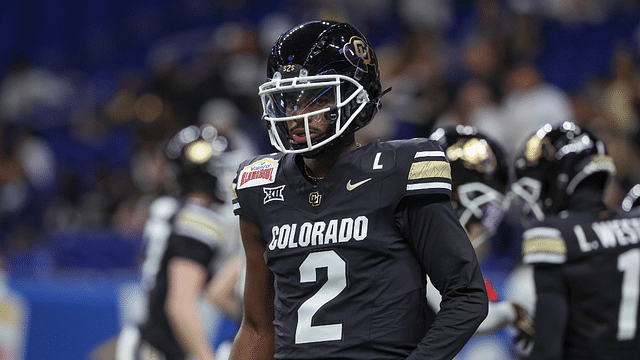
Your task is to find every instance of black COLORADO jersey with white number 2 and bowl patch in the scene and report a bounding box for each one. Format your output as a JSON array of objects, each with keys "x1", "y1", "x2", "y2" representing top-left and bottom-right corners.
[{"x1": 233, "y1": 139, "x2": 484, "y2": 360}]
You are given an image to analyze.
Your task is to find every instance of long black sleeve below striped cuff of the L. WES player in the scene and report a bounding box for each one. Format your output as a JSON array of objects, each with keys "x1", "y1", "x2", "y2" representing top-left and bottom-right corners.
[{"x1": 527, "y1": 265, "x2": 569, "y2": 360}]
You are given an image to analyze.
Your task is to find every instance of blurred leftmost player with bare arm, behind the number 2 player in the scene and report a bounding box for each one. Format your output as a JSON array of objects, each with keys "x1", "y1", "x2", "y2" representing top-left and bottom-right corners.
[{"x1": 117, "y1": 125, "x2": 238, "y2": 360}]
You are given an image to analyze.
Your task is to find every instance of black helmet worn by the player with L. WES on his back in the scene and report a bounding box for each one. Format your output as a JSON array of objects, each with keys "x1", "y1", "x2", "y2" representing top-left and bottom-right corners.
[{"x1": 511, "y1": 121, "x2": 616, "y2": 221}]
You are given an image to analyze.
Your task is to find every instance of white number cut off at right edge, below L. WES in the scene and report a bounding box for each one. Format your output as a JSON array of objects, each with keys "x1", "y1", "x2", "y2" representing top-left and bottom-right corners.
[{"x1": 616, "y1": 249, "x2": 640, "y2": 341}]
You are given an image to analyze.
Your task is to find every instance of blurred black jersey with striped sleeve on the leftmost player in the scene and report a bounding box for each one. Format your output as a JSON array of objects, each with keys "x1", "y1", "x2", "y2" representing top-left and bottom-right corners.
[{"x1": 140, "y1": 197, "x2": 233, "y2": 359}]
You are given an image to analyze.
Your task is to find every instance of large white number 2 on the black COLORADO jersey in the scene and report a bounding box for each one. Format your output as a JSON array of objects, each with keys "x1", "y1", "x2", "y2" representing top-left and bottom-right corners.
[{"x1": 296, "y1": 250, "x2": 347, "y2": 344}]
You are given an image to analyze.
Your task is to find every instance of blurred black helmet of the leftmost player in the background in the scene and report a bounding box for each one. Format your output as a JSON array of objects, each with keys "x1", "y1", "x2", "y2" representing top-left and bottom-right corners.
[{"x1": 165, "y1": 125, "x2": 227, "y2": 202}]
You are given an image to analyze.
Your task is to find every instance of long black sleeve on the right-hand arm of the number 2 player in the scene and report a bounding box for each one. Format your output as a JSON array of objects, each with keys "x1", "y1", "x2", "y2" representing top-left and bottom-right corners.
[{"x1": 397, "y1": 196, "x2": 489, "y2": 359}]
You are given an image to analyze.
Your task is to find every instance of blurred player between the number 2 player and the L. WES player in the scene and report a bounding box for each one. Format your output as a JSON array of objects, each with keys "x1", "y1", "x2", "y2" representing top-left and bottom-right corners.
[{"x1": 427, "y1": 125, "x2": 534, "y2": 355}]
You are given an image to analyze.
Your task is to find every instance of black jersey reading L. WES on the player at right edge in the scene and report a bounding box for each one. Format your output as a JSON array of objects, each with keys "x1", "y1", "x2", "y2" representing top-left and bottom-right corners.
[{"x1": 523, "y1": 192, "x2": 640, "y2": 360}]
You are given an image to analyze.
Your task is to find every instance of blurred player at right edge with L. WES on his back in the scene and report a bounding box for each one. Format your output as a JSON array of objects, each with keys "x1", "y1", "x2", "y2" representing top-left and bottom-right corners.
[{"x1": 513, "y1": 122, "x2": 640, "y2": 360}]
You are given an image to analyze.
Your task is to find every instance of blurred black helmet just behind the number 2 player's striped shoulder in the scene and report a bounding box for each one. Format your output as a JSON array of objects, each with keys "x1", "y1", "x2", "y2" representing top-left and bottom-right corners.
[{"x1": 430, "y1": 125, "x2": 509, "y2": 247}]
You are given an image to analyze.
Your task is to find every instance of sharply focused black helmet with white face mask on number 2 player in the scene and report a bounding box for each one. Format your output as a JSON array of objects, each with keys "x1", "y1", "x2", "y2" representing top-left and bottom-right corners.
[{"x1": 258, "y1": 20, "x2": 382, "y2": 156}]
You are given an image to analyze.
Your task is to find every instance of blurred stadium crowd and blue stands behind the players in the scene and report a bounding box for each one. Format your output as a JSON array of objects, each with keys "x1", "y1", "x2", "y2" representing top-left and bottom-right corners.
[{"x1": 0, "y1": 0, "x2": 640, "y2": 359}]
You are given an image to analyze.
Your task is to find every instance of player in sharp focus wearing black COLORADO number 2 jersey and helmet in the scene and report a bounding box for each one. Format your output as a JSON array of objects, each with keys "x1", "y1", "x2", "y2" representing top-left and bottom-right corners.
[{"x1": 231, "y1": 21, "x2": 488, "y2": 360}]
